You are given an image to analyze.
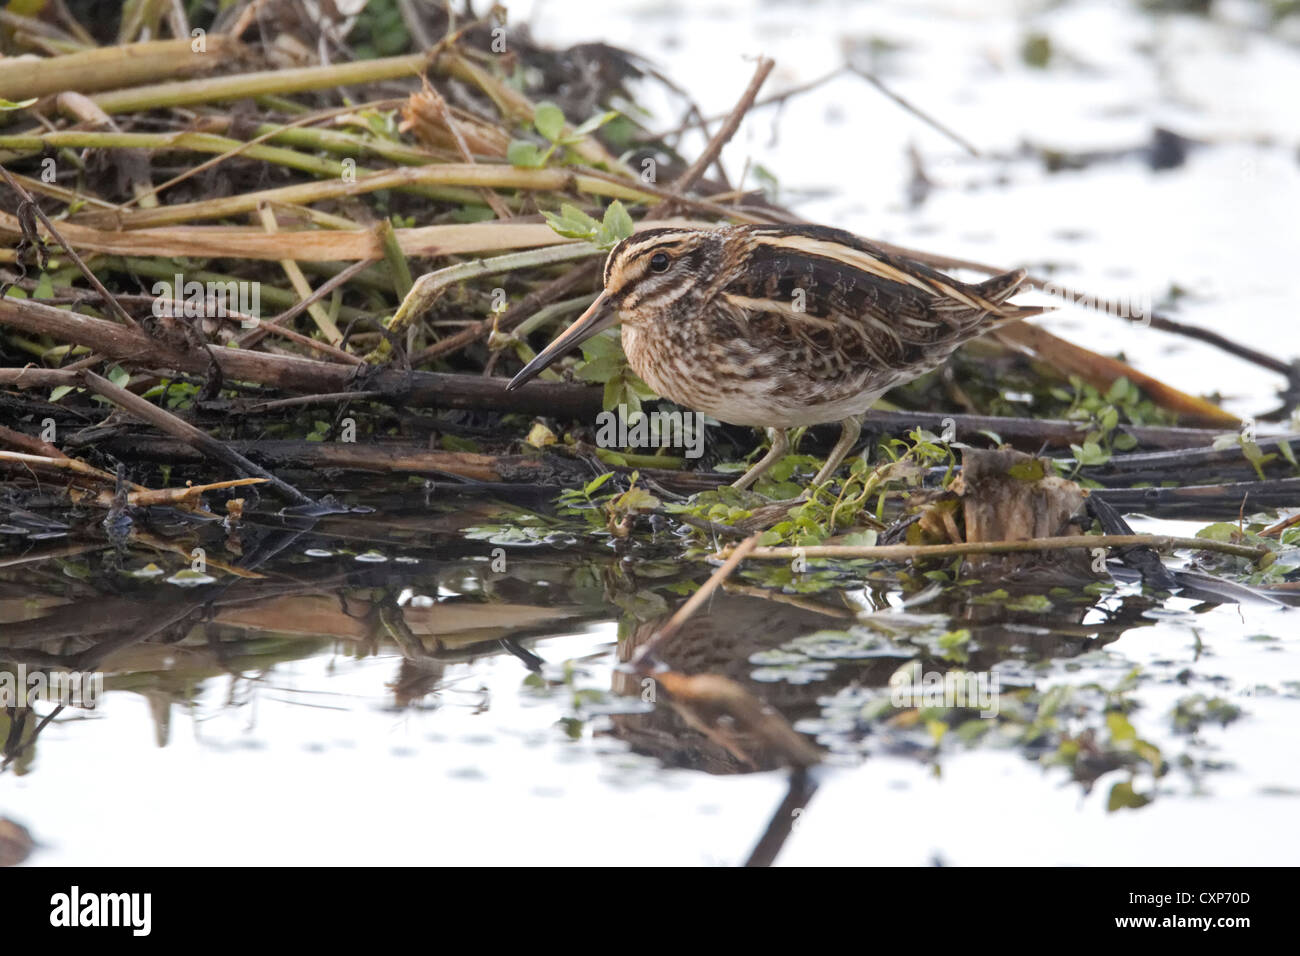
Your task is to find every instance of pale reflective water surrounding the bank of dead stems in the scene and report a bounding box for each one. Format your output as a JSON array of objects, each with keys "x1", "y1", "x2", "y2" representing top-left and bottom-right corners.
[{"x1": 0, "y1": 1, "x2": 1300, "y2": 865}]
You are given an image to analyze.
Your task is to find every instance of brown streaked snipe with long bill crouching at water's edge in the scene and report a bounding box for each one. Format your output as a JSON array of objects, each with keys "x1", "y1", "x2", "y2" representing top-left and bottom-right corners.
[{"x1": 507, "y1": 224, "x2": 1045, "y2": 489}]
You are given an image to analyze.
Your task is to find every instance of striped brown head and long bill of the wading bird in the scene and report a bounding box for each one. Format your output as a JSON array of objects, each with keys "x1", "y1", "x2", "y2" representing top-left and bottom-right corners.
[{"x1": 507, "y1": 229, "x2": 724, "y2": 389}]
